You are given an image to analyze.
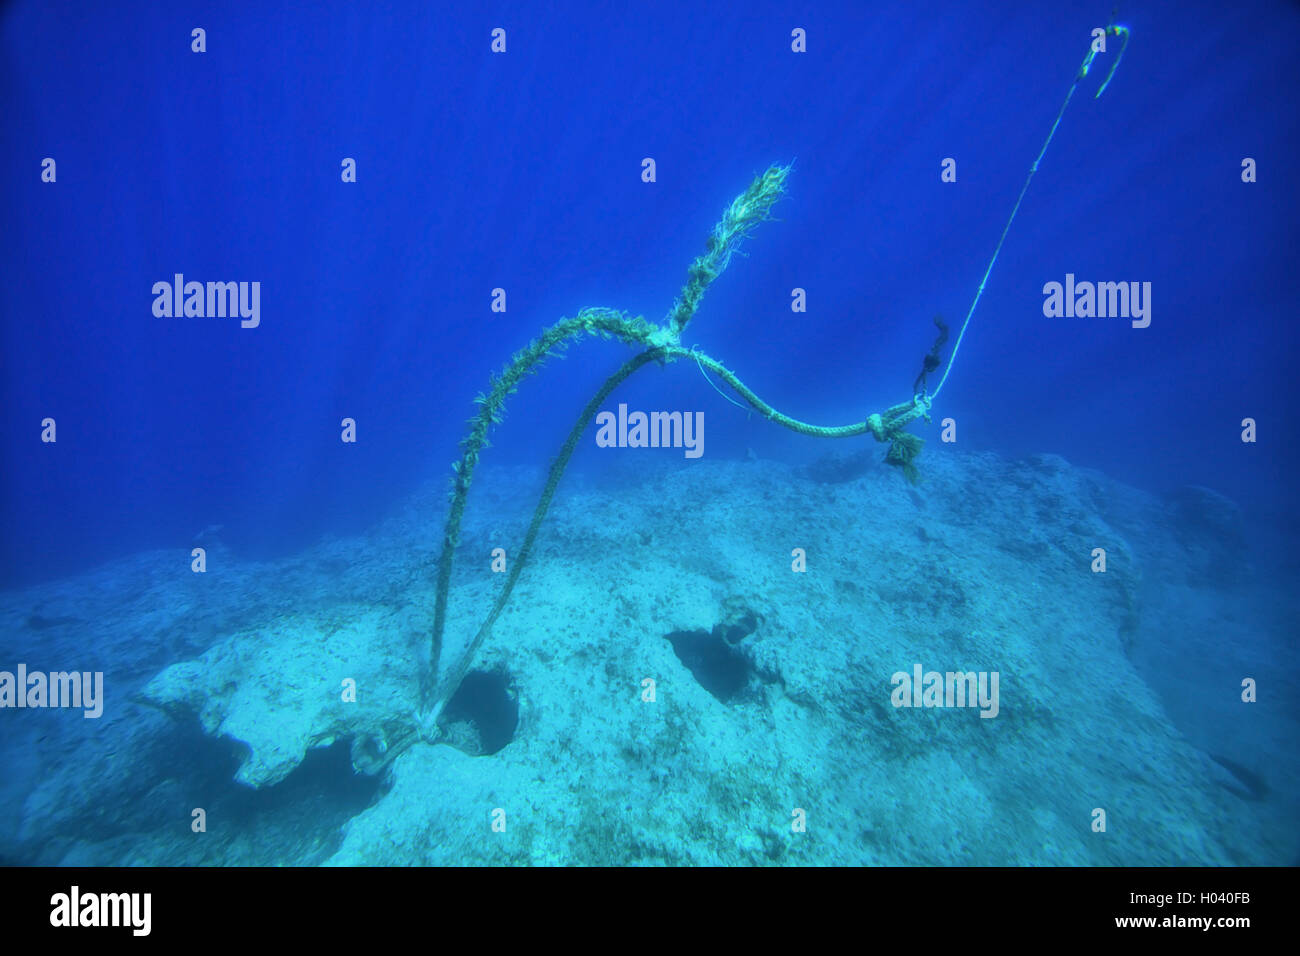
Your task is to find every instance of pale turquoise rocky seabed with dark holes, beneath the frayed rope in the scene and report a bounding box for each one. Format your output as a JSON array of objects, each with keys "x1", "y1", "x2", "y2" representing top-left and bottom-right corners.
[{"x1": 0, "y1": 451, "x2": 1300, "y2": 866}]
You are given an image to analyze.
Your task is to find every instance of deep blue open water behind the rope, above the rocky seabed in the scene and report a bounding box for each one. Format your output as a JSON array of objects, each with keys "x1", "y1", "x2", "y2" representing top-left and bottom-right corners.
[{"x1": 0, "y1": 0, "x2": 1300, "y2": 868}]
